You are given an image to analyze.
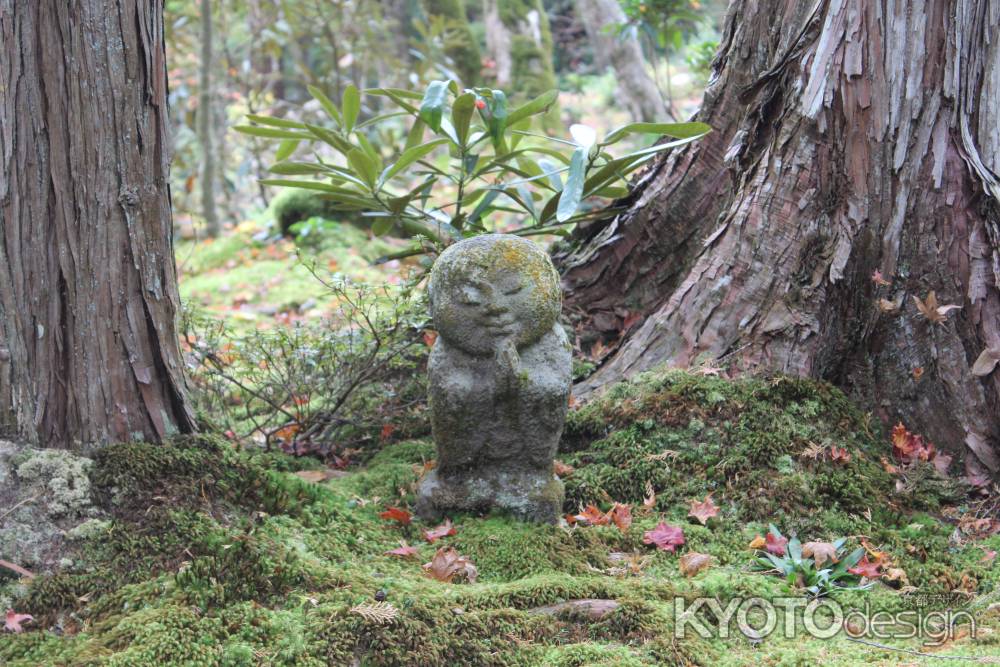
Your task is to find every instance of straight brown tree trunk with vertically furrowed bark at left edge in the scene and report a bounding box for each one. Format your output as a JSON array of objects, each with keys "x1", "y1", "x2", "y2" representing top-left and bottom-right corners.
[{"x1": 0, "y1": 0, "x2": 194, "y2": 446}]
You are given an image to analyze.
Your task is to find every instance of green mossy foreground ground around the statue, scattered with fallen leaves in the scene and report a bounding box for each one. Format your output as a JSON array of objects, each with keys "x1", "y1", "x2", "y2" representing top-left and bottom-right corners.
[{"x1": 0, "y1": 371, "x2": 1000, "y2": 667}]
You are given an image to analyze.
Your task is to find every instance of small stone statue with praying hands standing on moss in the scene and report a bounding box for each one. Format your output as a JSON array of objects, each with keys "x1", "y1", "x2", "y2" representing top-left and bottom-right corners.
[{"x1": 417, "y1": 234, "x2": 571, "y2": 522}]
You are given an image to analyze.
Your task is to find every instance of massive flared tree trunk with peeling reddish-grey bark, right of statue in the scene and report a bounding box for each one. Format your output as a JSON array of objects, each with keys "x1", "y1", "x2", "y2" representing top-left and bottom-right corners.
[{"x1": 557, "y1": 0, "x2": 1000, "y2": 480}]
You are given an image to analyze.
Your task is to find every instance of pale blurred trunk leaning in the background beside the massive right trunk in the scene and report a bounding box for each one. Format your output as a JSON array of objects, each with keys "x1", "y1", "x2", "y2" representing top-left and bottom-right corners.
[{"x1": 576, "y1": 0, "x2": 666, "y2": 122}]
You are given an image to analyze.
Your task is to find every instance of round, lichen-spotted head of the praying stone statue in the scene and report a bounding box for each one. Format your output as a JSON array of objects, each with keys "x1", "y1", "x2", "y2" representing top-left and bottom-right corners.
[{"x1": 428, "y1": 234, "x2": 562, "y2": 356}]
